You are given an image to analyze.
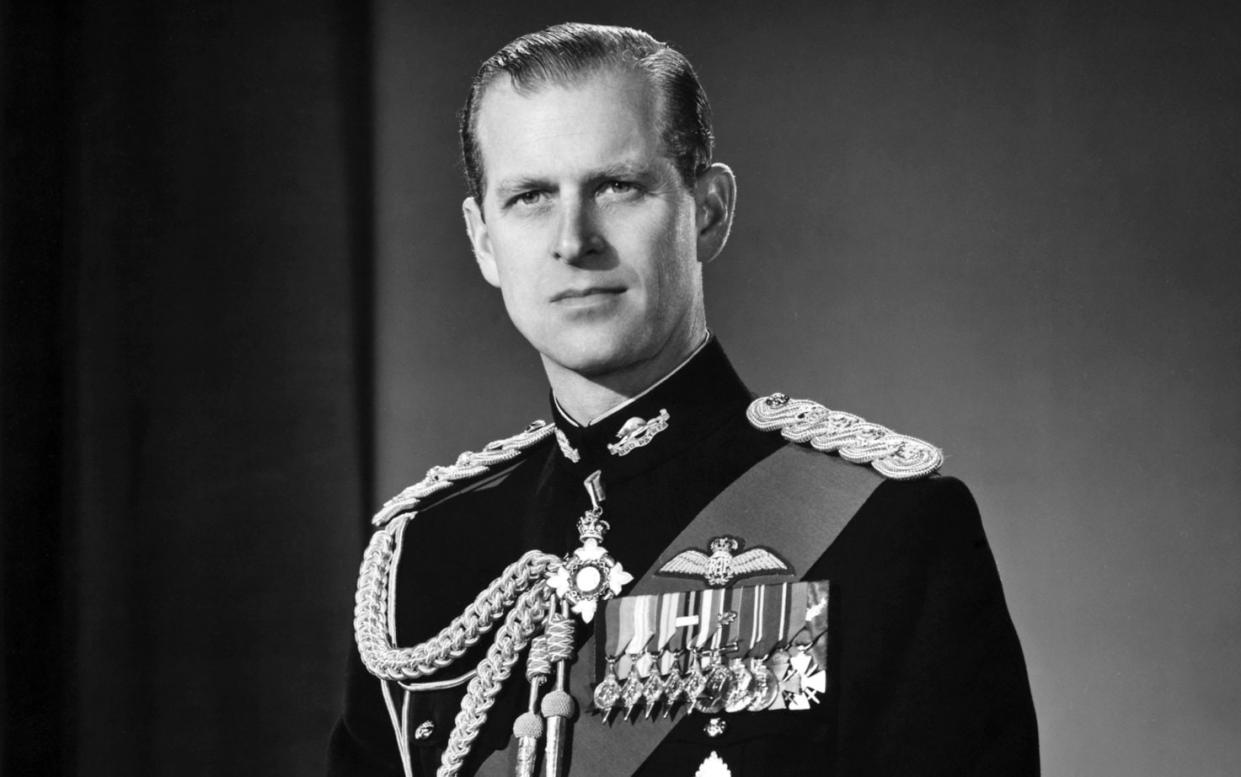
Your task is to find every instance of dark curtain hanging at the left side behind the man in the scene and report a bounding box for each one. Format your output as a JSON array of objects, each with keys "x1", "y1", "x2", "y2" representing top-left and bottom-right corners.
[{"x1": 0, "y1": 0, "x2": 371, "y2": 777}]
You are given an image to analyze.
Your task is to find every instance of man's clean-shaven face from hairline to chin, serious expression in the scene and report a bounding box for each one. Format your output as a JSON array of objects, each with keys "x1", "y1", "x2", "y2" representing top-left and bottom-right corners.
[{"x1": 464, "y1": 71, "x2": 710, "y2": 379}]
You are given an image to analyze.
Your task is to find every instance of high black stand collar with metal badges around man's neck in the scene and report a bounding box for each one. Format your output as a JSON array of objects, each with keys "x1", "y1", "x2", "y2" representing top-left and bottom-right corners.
[{"x1": 551, "y1": 335, "x2": 752, "y2": 483}]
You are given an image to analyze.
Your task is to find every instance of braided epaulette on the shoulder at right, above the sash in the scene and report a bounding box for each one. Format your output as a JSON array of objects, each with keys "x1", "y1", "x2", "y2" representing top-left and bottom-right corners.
[{"x1": 746, "y1": 393, "x2": 943, "y2": 480}]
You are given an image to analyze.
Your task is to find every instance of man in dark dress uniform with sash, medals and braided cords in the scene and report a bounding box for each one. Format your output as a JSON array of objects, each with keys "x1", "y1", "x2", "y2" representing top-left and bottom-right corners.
[{"x1": 330, "y1": 25, "x2": 1037, "y2": 777}]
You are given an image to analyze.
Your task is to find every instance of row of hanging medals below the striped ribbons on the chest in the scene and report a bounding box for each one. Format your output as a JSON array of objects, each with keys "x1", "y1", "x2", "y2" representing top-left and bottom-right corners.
[{"x1": 594, "y1": 645, "x2": 824, "y2": 722}]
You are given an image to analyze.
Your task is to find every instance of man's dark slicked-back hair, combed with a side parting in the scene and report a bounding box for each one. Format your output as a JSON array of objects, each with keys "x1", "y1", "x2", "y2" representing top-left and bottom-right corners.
[{"x1": 459, "y1": 22, "x2": 715, "y2": 207}]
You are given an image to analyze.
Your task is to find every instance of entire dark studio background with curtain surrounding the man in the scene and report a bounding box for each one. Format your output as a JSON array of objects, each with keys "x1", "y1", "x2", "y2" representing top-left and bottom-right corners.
[{"x1": 0, "y1": 0, "x2": 1241, "y2": 776}]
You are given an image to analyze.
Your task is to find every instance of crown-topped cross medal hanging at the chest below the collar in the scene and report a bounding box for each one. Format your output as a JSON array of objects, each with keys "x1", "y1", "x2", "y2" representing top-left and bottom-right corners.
[{"x1": 547, "y1": 470, "x2": 633, "y2": 623}]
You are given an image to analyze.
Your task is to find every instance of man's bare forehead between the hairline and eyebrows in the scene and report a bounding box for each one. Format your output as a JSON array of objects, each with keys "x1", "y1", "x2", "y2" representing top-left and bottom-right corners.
[{"x1": 477, "y1": 68, "x2": 661, "y2": 190}]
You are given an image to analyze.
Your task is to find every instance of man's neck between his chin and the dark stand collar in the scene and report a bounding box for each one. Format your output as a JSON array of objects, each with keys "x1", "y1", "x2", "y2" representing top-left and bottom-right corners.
[{"x1": 544, "y1": 325, "x2": 707, "y2": 426}]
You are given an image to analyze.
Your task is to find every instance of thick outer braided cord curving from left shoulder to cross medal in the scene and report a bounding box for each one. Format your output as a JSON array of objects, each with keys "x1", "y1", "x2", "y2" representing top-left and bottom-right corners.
[{"x1": 354, "y1": 515, "x2": 560, "y2": 686}]
